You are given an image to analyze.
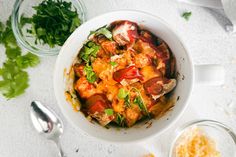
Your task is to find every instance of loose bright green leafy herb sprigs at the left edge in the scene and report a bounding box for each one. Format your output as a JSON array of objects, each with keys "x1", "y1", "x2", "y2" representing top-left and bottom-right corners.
[{"x1": 0, "y1": 18, "x2": 39, "y2": 99}]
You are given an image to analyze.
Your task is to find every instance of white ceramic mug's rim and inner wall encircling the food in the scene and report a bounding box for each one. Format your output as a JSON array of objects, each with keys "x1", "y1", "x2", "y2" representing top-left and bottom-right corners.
[{"x1": 54, "y1": 11, "x2": 194, "y2": 143}]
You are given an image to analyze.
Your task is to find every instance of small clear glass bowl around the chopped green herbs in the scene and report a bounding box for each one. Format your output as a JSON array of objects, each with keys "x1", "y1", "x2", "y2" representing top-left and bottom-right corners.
[{"x1": 11, "y1": 0, "x2": 86, "y2": 56}]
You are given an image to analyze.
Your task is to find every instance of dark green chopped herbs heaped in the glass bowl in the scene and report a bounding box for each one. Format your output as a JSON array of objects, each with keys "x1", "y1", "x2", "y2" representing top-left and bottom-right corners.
[{"x1": 23, "y1": 0, "x2": 81, "y2": 47}]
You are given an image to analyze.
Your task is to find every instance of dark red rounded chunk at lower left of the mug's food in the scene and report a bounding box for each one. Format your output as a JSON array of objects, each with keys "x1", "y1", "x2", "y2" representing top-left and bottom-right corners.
[{"x1": 86, "y1": 94, "x2": 109, "y2": 114}]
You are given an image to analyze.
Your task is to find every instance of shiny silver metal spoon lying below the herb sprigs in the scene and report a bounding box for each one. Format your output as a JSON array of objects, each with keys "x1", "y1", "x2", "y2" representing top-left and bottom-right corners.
[{"x1": 30, "y1": 101, "x2": 65, "y2": 157}]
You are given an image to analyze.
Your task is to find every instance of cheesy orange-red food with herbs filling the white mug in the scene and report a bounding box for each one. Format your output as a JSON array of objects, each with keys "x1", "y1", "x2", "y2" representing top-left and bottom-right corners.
[{"x1": 67, "y1": 20, "x2": 177, "y2": 127}]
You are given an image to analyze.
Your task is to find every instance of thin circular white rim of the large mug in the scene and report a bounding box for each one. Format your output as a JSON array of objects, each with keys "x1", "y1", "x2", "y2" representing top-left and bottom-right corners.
[{"x1": 53, "y1": 9, "x2": 195, "y2": 144}]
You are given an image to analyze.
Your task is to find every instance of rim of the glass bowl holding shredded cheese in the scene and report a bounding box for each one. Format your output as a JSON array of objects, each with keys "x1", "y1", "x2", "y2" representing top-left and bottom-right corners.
[{"x1": 168, "y1": 119, "x2": 236, "y2": 157}]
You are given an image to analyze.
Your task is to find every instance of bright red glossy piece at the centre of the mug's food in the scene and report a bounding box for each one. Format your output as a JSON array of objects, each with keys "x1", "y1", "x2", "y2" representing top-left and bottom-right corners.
[{"x1": 113, "y1": 66, "x2": 142, "y2": 82}]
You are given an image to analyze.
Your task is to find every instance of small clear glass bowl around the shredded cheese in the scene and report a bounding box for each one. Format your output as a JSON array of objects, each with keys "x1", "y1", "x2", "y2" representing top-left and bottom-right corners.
[{"x1": 169, "y1": 120, "x2": 236, "y2": 157}]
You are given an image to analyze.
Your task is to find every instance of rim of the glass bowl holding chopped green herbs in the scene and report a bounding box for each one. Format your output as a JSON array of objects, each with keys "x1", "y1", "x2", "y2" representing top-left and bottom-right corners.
[{"x1": 11, "y1": 0, "x2": 87, "y2": 57}]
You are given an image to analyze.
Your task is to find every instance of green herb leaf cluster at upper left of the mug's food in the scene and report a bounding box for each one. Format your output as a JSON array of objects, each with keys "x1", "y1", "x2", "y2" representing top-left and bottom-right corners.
[{"x1": 80, "y1": 41, "x2": 100, "y2": 63}]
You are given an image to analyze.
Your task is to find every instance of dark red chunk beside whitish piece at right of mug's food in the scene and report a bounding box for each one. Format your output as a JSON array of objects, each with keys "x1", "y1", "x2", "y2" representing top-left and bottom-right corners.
[{"x1": 144, "y1": 77, "x2": 163, "y2": 95}]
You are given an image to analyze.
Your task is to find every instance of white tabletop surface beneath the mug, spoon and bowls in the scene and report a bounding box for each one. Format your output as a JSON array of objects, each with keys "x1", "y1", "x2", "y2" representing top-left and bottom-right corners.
[{"x1": 0, "y1": 0, "x2": 236, "y2": 157}]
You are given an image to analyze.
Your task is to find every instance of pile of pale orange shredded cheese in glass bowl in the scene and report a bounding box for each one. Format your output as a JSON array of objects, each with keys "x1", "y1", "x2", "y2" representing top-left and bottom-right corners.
[{"x1": 174, "y1": 127, "x2": 221, "y2": 157}]
